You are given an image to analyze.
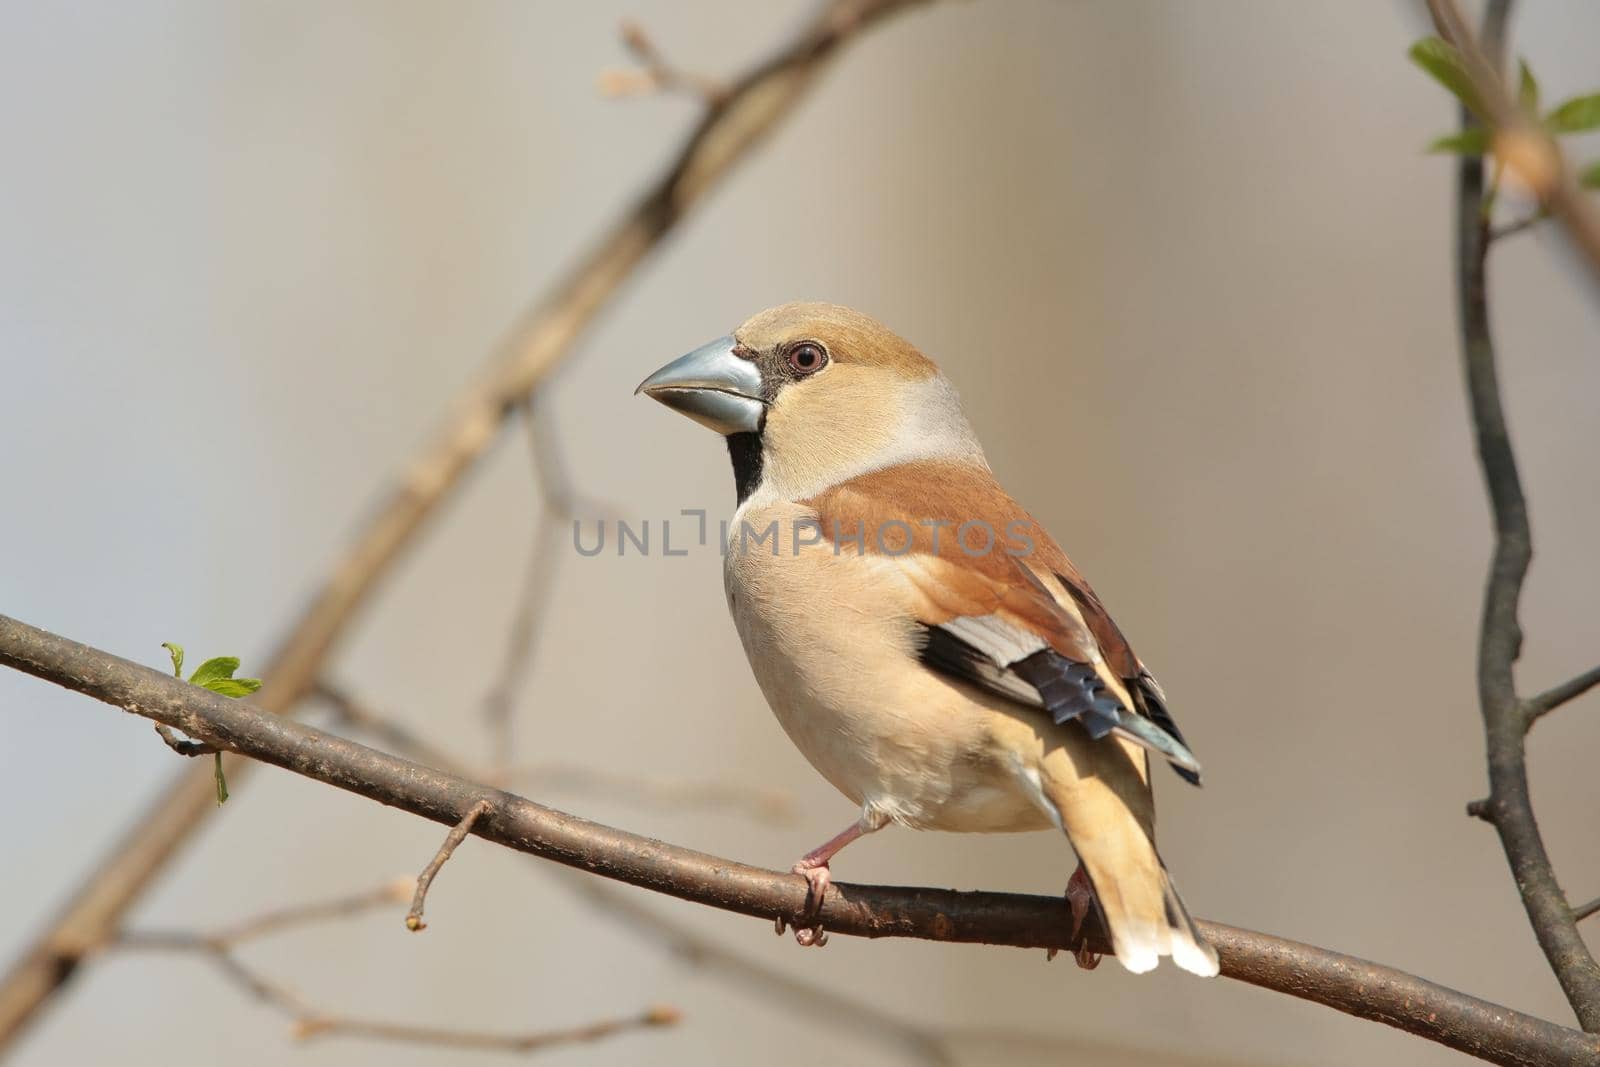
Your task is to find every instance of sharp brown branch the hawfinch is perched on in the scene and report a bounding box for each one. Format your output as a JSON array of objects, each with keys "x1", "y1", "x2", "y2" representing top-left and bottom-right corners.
[{"x1": 0, "y1": 616, "x2": 1600, "y2": 1067}]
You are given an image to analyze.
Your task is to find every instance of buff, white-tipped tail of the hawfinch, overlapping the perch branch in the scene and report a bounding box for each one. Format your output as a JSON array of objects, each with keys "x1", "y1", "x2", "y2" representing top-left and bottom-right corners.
[{"x1": 1072, "y1": 833, "x2": 1218, "y2": 977}]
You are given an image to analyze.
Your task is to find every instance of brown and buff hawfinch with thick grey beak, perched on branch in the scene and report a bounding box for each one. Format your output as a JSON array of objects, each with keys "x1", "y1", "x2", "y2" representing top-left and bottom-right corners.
[{"x1": 638, "y1": 304, "x2": 1218, "y2": 976}]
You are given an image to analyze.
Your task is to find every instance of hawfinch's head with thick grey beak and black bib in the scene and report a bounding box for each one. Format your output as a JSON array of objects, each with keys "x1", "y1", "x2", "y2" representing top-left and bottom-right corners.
[{"x1": 637, "y1": 304, "x2": 982, "y2": 502}]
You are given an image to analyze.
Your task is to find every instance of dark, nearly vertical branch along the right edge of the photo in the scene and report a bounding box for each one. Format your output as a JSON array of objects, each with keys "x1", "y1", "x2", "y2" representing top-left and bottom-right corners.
[{"x1": 1429, "y1": 0, "x2": 1600, "y2": 1032}]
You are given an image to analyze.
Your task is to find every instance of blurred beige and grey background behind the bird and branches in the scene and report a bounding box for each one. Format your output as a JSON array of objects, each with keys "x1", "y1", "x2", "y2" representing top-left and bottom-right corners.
[{"x1": 0, "y1": 0, "x2": 1600, "y2": 1067}]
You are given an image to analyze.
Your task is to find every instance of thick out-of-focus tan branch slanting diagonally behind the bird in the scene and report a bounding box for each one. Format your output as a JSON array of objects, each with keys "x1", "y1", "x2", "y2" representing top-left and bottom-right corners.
[{"x1": 0, "y1": 0, "x2": 920, "y2": 1048}]
